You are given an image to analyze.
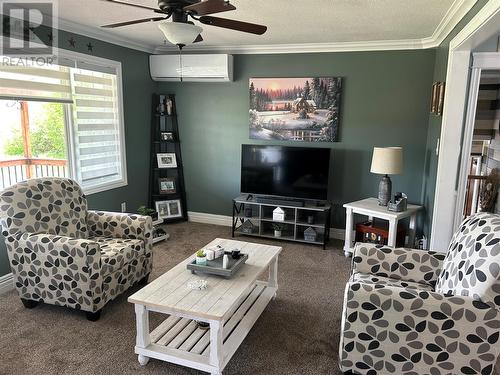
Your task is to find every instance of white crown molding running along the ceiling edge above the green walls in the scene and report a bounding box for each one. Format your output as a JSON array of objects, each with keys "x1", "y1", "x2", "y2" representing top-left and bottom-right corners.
[{"x1": 47, "y1": 0, "x2": 477, "y2": 54}]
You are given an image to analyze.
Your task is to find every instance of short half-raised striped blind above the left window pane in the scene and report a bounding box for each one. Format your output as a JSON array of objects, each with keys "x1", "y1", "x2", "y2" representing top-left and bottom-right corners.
[{"x1": 0, "y1": 65, "x2": 72, "y2": 103}]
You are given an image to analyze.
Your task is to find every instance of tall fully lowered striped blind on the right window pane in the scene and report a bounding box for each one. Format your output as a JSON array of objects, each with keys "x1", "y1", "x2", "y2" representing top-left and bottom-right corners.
[{"x1": 70, "y1": 61, "x2": 125, "y2": 191}]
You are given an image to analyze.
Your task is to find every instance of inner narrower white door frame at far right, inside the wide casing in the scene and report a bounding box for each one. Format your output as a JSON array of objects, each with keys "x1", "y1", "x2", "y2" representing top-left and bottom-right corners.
[{"x1": 453, "y1": 52, "x2": 500, "y2": 228}]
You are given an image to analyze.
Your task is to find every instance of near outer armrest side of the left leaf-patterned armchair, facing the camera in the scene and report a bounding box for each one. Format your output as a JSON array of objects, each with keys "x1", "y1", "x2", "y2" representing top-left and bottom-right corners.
[{"x1": 10, "y1": 233, "x2": 102, "y2": 310}]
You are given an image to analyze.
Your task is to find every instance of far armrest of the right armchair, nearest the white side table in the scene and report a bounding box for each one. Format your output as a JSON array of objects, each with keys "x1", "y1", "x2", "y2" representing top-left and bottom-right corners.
[{"x1": 352, "y1": 243, "x2": 445, "y2": 286}]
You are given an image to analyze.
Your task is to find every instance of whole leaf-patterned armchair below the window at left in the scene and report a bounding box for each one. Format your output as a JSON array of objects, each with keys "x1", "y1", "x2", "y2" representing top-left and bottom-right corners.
[{"x1": 0, "y1": 178, "x2": 153, "y2": 320}]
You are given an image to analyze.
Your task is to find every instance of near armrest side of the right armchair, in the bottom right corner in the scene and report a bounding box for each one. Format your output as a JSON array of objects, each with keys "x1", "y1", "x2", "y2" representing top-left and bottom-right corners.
[{"x1": 339, "y1": 282, "x2": 500, "y2": 374}]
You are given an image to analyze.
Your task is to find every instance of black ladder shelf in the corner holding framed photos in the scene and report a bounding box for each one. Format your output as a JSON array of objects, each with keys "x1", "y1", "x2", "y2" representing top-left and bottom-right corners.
[{"x1": 148, "y1": 94, "x2": 188, "y2": 223}]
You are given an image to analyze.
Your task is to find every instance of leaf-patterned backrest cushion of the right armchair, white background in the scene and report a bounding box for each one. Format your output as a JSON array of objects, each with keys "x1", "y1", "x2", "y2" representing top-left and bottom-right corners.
[{"x1": 436, "y1": 212, "x2": 500, "y2": 309}]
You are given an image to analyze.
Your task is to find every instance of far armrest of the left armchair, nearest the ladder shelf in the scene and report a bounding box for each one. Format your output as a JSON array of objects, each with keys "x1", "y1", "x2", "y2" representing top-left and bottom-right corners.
[{"x1": 87, "y1": 210, "x2": 153, "y2": 252}]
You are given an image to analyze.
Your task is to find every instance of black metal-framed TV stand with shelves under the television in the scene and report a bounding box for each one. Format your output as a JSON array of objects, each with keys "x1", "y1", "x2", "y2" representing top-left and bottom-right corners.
[{"x1": 232, "y1": 194, "x2": 331, "y2": 249}]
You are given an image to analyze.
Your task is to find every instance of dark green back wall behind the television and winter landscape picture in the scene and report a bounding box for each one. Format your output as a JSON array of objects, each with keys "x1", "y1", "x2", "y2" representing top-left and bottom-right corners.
[{"x1": 159, "y1": 50, "x2": 435, "y2": 228}]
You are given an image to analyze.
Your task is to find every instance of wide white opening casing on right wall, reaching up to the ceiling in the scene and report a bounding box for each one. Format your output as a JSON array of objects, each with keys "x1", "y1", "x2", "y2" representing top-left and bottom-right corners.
[{"x1": 430, "y1": 0, "x2": 500, "y2": 252}]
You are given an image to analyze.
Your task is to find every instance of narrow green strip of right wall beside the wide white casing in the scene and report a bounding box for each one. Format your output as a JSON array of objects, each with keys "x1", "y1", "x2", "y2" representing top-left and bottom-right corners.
[{"x1": 423, "y1": 0, "x2": 488, "y2": 235}]
